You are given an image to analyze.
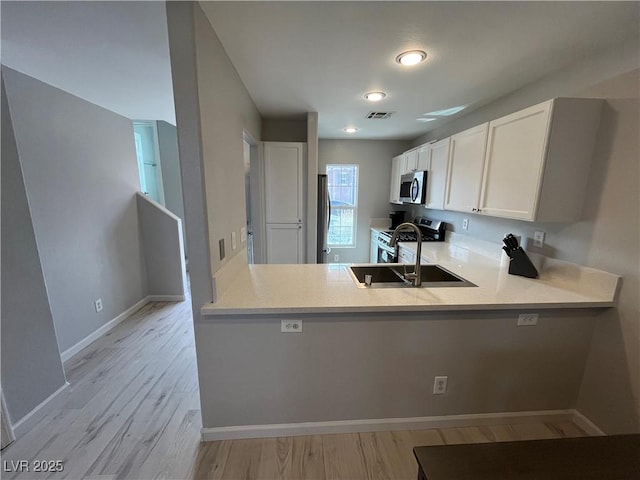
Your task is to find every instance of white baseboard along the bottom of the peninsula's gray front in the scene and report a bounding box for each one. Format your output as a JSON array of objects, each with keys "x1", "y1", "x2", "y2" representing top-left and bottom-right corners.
[{"x1": 200, "y1": 410, "x2": 576, "y2": 442}]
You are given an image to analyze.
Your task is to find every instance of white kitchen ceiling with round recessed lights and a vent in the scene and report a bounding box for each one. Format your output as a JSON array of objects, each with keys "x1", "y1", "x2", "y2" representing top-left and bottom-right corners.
[{"x1": 201, "y1": 1, "x2": 639, "y2": 139}]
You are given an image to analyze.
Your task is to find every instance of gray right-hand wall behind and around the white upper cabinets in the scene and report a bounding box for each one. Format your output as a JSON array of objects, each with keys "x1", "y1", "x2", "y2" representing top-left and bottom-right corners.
[{"x1": 408, "y1": 44, "x2": 640, "y2": 433}]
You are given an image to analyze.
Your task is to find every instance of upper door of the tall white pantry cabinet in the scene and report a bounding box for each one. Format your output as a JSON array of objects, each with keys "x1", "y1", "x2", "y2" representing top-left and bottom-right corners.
[{"x1": 262, "y1": 142, "x2": 305, "y2": 223}]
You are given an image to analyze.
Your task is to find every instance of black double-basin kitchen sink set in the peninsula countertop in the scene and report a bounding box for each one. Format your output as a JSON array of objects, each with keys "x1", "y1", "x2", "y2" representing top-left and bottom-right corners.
[{"x1": 349, "y1": 263, "x2": 476, "y2": 288}]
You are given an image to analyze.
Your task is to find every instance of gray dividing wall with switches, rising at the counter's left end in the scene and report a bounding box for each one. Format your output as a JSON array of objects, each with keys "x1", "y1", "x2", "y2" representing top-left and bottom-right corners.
[{"x1": 167, "y1": 2, "x2": 261, "y2": 310}]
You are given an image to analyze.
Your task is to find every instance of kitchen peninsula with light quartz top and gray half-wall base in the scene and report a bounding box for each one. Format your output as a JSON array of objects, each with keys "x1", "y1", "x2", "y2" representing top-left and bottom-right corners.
[{"x1": 195, "y1": 239, "x2": 620, "y2": 440}]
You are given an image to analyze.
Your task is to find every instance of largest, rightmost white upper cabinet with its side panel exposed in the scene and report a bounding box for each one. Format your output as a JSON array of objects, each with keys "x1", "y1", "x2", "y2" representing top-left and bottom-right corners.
[{"x1": 478, "y1": 98, "x2": 602, "y2": 222}]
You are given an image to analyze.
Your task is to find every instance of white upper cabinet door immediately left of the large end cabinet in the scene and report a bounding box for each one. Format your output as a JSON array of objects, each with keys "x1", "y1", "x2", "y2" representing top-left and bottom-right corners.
[{"x1": 444, "y1": 123, "x2": 489, "y2": 212}]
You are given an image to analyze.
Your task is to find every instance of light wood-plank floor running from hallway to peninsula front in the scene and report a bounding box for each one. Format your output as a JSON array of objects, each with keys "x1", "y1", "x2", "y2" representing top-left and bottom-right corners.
[{"x1": 1, "y1": 301, "x2": 585, "y2": 480}]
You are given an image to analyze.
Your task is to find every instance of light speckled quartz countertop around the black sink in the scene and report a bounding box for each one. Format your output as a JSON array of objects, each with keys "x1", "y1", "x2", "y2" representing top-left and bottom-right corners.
[{"x1": 201, "y1": 239, "x2": 620, "y2": 316}]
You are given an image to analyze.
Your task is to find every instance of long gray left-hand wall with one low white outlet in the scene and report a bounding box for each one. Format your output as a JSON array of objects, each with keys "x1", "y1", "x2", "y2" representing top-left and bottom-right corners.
[{"x1": 5, "y1": 69, "x2": 146, "y2": 352}]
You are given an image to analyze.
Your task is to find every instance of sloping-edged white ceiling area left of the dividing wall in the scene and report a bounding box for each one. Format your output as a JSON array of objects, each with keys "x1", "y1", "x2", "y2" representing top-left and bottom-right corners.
[{"x1": 1, "y1": 0, "x2": 175, "y2": 125}]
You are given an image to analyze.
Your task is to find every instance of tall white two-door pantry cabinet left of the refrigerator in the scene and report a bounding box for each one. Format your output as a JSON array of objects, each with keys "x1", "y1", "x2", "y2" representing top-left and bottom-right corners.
[{"x1": 261, "y1": 142, "x2": 306, "y2": 263}]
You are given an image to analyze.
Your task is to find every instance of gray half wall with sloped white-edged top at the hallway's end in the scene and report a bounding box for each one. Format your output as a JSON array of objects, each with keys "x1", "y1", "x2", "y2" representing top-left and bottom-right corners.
[{"x1": 136, "y1": 193, "x2": 187, "y2": 297}]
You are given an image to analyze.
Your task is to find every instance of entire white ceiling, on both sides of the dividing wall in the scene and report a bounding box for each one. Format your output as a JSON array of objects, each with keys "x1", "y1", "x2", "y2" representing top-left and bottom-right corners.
[{"x1": 1, "y1": 1, "x2": 640, "y2": 139}]
